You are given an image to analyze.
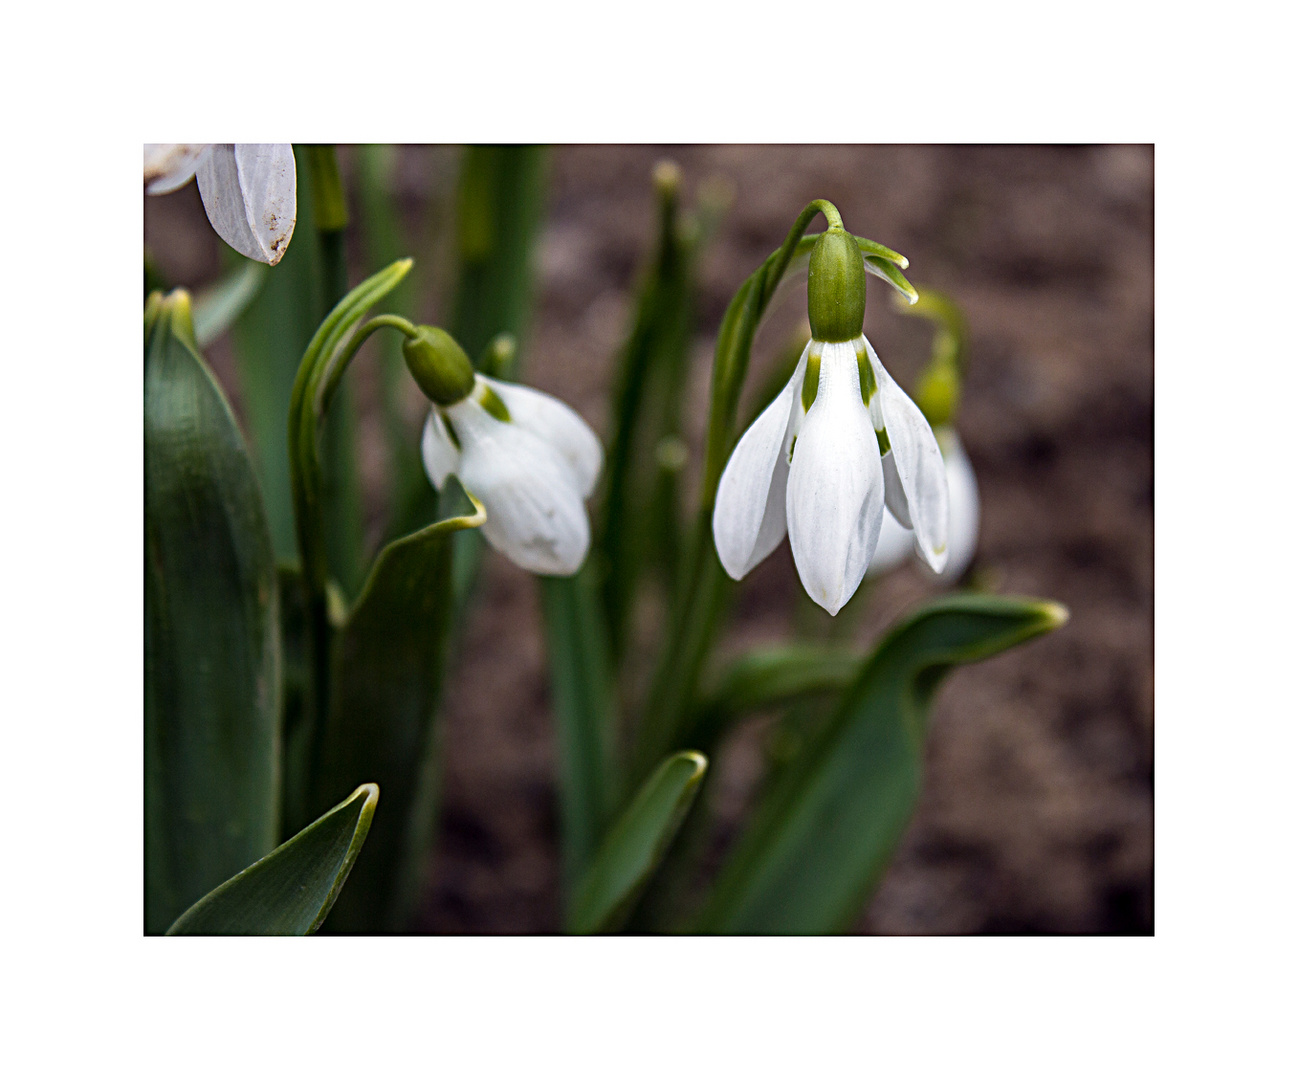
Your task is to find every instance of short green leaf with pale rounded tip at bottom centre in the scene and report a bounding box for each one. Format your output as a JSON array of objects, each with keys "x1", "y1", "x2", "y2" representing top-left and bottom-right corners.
[{"x1": 567, "y1": 750, "x2": 707, "y2": 933}]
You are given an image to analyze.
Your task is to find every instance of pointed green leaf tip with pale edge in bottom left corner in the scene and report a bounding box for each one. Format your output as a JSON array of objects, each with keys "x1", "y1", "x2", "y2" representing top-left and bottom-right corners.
[{"x1": 167, "y1": 784, "x2": 379, "y2": 935}]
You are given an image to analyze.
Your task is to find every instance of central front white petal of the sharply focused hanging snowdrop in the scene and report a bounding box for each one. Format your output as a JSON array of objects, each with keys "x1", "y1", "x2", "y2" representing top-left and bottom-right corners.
[{"x1": 787, "y1": 341, "x2": 884, "y2": 615}]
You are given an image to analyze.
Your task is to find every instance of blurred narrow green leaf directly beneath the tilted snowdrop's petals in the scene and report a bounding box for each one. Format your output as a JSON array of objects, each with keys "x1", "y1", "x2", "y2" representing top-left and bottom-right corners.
[{"x1": 539, "y1": 562, "x2": 617, "y2": 898}]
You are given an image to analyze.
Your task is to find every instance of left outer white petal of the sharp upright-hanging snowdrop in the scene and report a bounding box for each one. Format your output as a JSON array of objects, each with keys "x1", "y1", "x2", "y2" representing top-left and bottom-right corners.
[{"x1": 713, "y1": 341, "x2": 811, "y2": 582}]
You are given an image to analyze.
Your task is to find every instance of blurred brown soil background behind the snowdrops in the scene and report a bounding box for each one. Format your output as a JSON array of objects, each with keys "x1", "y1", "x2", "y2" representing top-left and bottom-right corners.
[{"x1": 145, "y1": 145, "x2": 1154, "y2": 933}]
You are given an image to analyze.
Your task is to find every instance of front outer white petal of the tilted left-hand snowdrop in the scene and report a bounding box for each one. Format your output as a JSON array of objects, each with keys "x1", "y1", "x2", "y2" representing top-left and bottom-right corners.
[{"x1": 447, "y1": 397, "x2": 591, "y2": 575}]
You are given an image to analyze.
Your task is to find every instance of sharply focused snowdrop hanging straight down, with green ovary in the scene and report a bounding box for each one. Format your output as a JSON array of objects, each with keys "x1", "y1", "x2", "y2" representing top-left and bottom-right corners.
[{"x1": 713, "y1": 226, "x2": 948, "y2": 615}]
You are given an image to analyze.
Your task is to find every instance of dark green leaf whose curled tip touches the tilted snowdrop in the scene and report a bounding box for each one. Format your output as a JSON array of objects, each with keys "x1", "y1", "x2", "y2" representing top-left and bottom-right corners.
[{"x1": 306, "y1": 485, "x2": 485, "y2": 933}]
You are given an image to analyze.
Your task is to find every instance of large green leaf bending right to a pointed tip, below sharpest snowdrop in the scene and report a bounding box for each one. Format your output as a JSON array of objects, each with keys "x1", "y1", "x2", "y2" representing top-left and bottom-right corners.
[{"x1": 693, "y1": 595, "x2": 1067, "y2": 933}]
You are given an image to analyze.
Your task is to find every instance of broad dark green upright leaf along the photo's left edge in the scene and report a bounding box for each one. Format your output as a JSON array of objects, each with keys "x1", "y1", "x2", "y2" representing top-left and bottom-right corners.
[{"x1": 144, "y1": 292, "x2": 280, "y2": 933}]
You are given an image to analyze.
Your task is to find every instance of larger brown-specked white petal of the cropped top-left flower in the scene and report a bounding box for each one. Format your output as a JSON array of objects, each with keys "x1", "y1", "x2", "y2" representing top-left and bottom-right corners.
[{"x1": 199, "y1": 143, "x2": 297, "y2": 266}]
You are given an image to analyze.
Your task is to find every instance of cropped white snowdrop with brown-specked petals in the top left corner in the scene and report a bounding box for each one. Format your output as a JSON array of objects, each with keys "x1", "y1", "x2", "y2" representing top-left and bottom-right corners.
[{"x1": 144, "y1": 143, "x2": 297, "y2": 266}]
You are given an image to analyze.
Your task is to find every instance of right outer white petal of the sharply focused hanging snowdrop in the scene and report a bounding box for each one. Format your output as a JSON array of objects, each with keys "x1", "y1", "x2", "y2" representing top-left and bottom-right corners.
[{"x1": 866, "y1": 340, "x2": 950, "y2": 574}]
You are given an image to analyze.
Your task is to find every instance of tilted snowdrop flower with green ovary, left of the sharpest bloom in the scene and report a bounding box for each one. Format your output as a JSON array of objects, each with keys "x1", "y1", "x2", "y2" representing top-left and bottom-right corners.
[{"x1": 404, "y1": 326, "x2": 604, "y2": 576}]
